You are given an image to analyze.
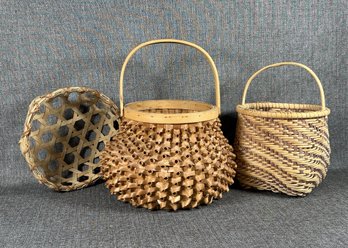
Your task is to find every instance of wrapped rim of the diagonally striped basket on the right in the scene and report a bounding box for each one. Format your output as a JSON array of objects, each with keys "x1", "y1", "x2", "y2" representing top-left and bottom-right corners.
[{"x1": 236, "y1": 102, "x2": 330, "y2": 119}]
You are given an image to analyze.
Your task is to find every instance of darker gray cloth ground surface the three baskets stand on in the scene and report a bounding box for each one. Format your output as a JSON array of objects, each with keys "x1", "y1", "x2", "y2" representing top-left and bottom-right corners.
[{"x1": 0, "y1": 170, "x2": 348, "y2": 248}]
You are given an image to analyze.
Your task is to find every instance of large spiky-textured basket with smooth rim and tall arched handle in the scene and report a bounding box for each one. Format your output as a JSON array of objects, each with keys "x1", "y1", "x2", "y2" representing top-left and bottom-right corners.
[{"x1": 101, "y1": 39, "x2": 236, "y2": 210}]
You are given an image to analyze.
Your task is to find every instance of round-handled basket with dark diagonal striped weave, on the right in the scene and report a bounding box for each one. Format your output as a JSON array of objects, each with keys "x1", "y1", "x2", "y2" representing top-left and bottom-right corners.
[{"x1": 235, "y1": 62, "x2": 330, "y2": 196}]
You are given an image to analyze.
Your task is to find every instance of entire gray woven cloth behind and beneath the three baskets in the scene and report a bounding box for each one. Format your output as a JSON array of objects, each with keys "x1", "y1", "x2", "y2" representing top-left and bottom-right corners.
[{"x1": 0, "y1": 0, "x2": 348, "y2": 247}]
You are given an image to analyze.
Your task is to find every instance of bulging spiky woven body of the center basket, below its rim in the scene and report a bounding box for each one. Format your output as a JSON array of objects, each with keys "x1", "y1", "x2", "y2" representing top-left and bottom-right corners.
[{"x1": 101, "y1": 119, "x2": 236, "y2": 210}]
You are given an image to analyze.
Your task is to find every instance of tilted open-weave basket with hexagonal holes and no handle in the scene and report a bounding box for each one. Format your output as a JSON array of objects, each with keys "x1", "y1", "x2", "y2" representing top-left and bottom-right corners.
[{"x1": 20, "y1": 87, "x2": 119, "y2": 191}]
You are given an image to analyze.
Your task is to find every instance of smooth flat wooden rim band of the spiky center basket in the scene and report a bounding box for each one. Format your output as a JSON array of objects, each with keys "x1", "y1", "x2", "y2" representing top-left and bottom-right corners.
[{"x1": 123, "y1": 100, "x2": 219, "y2": 124}]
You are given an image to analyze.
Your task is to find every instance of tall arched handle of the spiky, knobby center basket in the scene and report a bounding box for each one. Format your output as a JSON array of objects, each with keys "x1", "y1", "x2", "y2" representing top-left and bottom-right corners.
[{"x1": 120, "y1": 39, "x2": 221, "y2": 117}]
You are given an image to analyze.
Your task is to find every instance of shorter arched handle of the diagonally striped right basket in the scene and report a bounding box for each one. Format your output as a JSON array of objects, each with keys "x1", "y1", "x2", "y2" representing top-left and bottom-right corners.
[{"x1": 242, "y1": 62, "x2": 326, "y2": 110}]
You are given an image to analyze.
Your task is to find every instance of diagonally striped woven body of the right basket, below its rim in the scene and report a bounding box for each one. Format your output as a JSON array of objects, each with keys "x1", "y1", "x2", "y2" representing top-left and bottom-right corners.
[{"x1": 235, "y1": 104, "x2": 330, "y2": 196}]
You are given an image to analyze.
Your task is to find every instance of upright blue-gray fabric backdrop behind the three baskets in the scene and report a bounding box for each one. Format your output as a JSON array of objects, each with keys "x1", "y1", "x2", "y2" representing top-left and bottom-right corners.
[{"x1": 0, "y1": 0, "x2": 348, "y2": 247}]
